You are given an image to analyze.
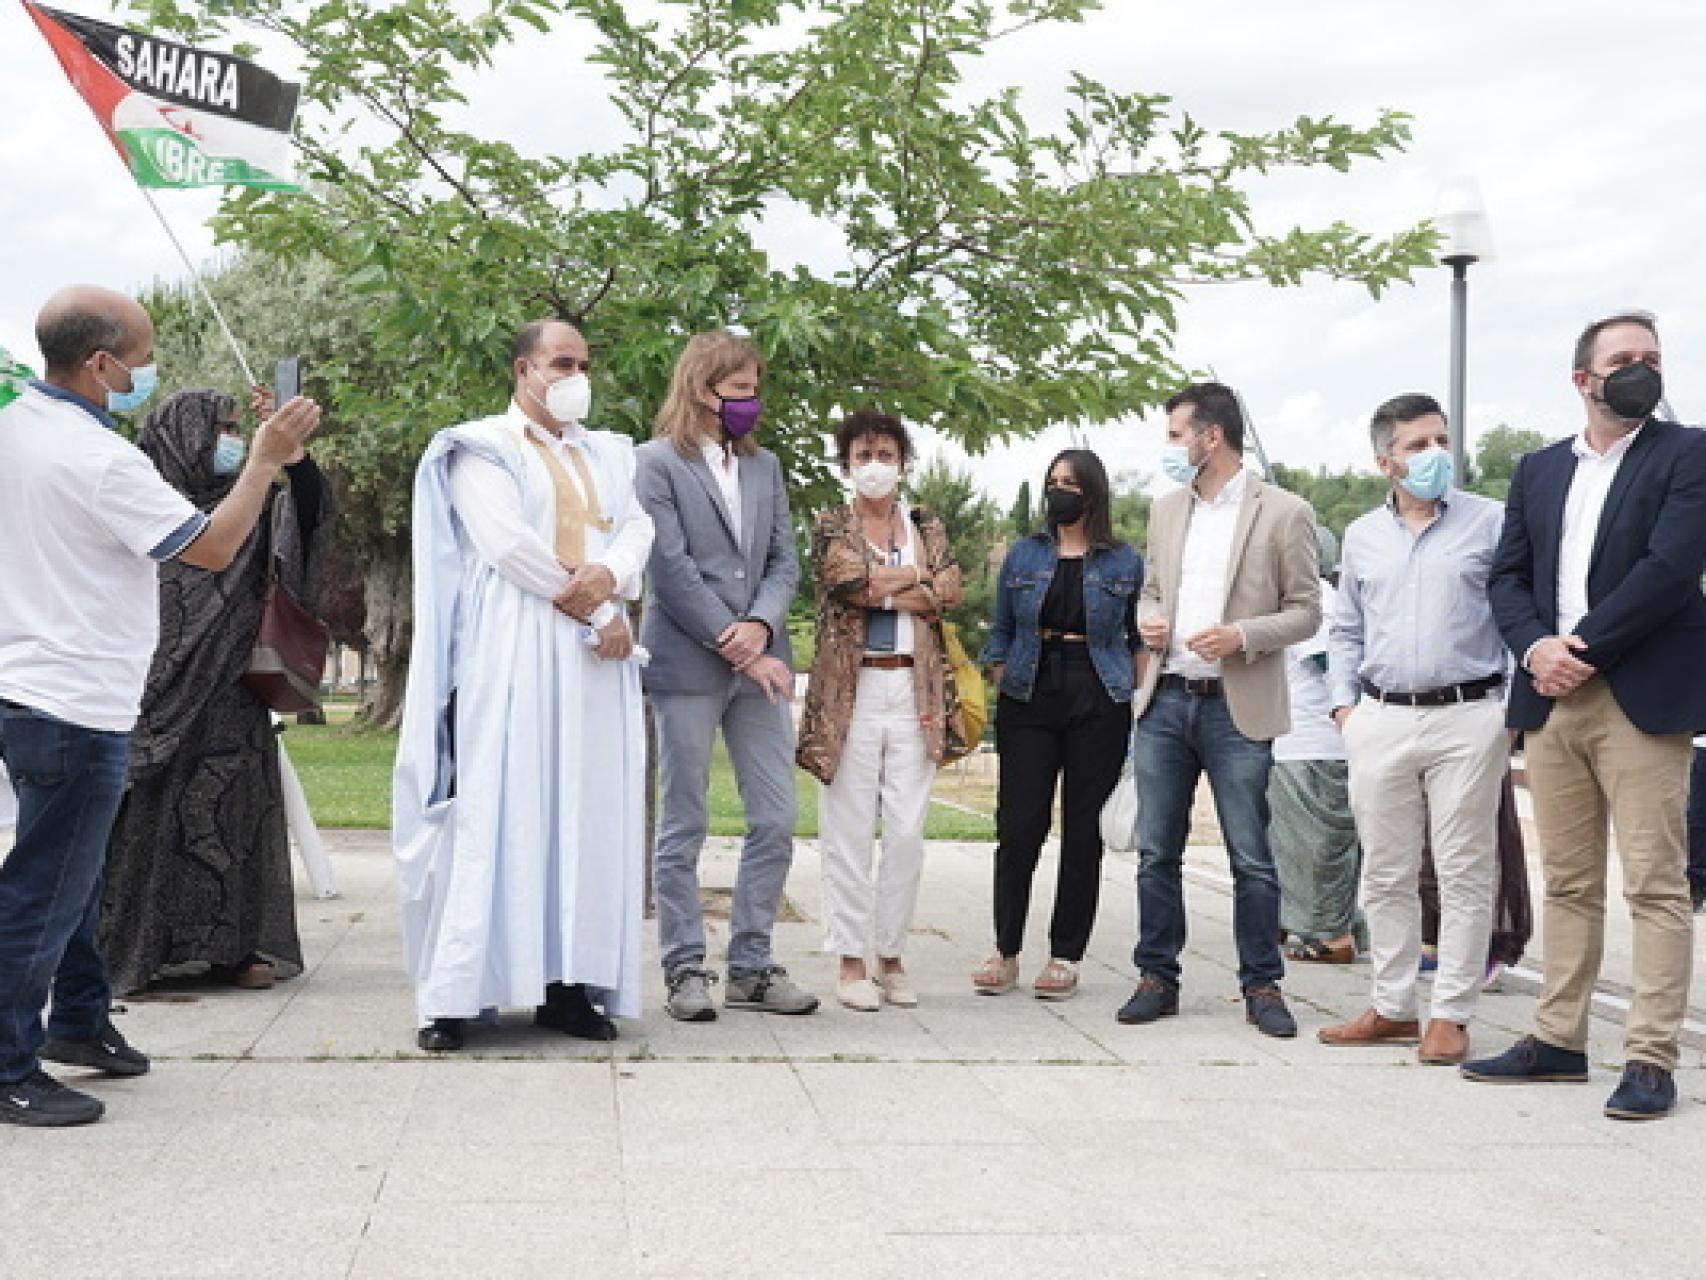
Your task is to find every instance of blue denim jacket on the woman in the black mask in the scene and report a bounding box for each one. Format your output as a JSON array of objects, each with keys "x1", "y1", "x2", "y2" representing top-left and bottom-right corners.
[{"x1": 979, "y1": 534, "x2": 1143, "y2": 701}]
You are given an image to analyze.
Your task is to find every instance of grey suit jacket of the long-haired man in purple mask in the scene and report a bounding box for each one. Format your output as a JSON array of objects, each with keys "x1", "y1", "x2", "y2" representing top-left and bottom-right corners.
[{"x1": 635, "y1": 440, "x2": 800, "y2": 693}]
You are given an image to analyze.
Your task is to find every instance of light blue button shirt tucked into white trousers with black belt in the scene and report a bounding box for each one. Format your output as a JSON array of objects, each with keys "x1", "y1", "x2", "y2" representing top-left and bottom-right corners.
[{"x1": 1329, "y1": 490, "x2": 1510, "y2": 707}]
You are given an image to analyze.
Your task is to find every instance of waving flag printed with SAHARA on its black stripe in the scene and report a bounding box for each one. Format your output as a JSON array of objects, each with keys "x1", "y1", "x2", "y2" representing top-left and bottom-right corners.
[{"x1": 24, "y1": 0, "x2": 300, "y2": 191}]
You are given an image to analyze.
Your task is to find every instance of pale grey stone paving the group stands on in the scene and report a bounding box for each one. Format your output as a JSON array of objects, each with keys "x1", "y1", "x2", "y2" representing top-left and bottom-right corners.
[{"x1": 0, "y1": 833, "x2": 1706, "y2": 1280}]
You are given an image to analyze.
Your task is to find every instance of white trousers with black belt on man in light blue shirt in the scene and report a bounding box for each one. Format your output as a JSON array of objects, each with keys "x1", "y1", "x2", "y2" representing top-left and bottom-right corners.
[{"x1": 1344, "y1": 698, "x2": 1510, "y2": 1026}]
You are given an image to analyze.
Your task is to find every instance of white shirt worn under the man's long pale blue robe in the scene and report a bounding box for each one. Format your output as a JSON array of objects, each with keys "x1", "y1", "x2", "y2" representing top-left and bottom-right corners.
[{"x1": 450, "y1": 404, "x2": 652, "y2": 628}]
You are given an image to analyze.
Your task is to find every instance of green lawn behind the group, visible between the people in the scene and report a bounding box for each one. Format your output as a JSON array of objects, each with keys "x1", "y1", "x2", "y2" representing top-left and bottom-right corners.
[{"x1": 283, "y1": 724, "x2": 995, "y2": 841}]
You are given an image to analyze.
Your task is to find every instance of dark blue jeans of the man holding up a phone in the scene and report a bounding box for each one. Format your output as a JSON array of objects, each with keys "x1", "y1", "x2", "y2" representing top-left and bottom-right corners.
[{"x1": 0, "y1": 701, "x2": 130, "y2": 1084}]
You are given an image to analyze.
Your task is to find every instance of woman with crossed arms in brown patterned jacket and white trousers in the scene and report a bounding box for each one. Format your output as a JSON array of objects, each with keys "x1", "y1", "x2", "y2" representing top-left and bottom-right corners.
[{"x1": 798, "y1": 410, "x2": 960, "y2": 1012}]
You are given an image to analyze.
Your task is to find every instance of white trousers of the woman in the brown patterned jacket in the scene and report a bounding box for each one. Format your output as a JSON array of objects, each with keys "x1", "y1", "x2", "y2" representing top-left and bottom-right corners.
[{"x1": 817, "y1": 667, "x2": 935, "y2": 959}]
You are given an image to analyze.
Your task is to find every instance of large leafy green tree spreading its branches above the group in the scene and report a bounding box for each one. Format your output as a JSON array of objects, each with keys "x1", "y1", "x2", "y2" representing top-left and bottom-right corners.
[{"x1": 130, "y1": 0, "x2": 1433, "y2": 716}]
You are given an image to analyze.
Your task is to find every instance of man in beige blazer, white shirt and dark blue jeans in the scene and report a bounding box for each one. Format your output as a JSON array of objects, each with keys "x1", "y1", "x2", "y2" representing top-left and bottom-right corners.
[{"x1": 1119, "y1": 382, "x2": 1320, "y2": 1038}]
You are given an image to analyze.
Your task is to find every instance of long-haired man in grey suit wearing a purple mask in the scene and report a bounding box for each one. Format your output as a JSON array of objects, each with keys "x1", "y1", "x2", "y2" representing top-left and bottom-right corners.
[{"x1": 635, "y1": 329, "x2": 817, "y2": 1022}]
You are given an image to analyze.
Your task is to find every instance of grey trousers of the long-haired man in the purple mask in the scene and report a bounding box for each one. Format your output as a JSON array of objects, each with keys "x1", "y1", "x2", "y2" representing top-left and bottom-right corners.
[{"x1": 652, "y1": 692, "x2": 795, "y2": 975}]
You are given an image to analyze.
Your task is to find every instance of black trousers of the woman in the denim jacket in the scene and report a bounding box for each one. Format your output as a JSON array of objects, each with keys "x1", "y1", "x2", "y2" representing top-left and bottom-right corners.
[{"x1": 995, "y1": 643, "x2": 1131, "y2": 961}]
